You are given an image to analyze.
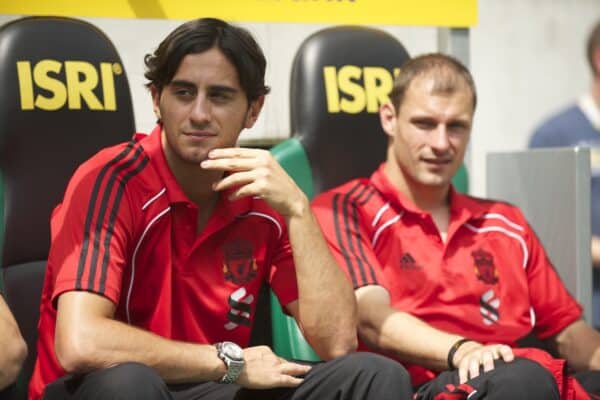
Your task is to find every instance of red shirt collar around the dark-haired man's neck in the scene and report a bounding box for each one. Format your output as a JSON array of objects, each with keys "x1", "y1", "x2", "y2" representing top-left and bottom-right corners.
[{"x1": 136, "y1": 124, "x2": 253, "y2": 216}]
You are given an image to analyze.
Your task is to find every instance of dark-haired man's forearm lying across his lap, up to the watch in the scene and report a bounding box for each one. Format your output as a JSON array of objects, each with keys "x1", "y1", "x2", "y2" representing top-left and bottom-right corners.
[{"x1": 56, "y1": 317, "x2": 225, "y2": 383}]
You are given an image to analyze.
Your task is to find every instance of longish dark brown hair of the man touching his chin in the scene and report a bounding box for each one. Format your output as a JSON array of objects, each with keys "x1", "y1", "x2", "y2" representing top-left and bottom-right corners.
[{"x1": 144, "y1": 18, "x2": 269, "y2": 101}]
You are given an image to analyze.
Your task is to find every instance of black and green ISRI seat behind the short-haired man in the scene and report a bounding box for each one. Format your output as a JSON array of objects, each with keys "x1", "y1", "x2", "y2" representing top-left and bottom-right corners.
[{"x1": 271, "y1": 26, "x2": 467, "y2": 360}]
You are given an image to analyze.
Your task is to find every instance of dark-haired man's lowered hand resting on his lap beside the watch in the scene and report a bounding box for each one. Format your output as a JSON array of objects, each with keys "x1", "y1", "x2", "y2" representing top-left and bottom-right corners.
[{"x1": 236, "y1": 346, "x2": 311, "y2": 389}]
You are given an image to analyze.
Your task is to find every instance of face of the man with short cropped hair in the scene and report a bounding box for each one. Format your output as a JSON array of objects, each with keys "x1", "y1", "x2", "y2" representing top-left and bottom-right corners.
[{"x1": 380, "y1": 76, "x2": 473, "y2": 192}]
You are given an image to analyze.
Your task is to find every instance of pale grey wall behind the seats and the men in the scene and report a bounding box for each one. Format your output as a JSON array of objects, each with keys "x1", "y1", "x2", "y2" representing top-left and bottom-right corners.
[{"x1": 0, "y1": 0, "x2": 600, "y2": 196}]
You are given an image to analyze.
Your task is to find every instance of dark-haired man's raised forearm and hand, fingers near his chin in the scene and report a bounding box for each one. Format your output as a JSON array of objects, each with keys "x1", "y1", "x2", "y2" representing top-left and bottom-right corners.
[{"x1": 201, "y1": 148, "x2": 357, "y2": 360}]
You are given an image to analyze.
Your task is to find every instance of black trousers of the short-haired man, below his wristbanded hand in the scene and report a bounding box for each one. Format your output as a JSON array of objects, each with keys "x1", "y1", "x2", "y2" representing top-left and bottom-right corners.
[{"x1": 415, "y1": 358, "x2": 600, "y2": 400}]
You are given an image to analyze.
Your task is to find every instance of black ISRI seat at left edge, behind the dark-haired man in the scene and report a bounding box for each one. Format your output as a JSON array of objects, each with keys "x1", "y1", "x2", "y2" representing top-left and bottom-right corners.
[{"x1": 0, "y1": 17, "x2": 135, "y2": 399}]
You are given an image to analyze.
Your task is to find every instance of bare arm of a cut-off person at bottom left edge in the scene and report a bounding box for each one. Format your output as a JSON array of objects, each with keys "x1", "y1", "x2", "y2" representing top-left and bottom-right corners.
[{"x1": 0, "y1": 295, "x2": 27, "y2": 390}]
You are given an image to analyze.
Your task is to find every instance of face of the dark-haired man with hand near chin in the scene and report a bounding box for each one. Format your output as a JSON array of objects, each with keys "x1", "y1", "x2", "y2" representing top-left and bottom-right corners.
[{"x1": 152, "y1": 48, "x2": 264, "y2": 167}]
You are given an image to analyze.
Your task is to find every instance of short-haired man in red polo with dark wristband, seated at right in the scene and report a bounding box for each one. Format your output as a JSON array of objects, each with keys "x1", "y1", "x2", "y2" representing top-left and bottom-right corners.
[{"x1": 313, "y1": 54, "x2": 600, "y2": 399}]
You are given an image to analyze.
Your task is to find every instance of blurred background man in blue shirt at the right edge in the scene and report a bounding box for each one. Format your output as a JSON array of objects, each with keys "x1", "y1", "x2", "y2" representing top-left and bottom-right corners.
[{"x1": 529, "y1": 20, "x2": 600, "y2": 329}]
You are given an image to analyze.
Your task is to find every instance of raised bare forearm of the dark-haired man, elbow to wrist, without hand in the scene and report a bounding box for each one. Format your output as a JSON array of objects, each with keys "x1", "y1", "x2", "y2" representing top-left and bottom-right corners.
[{"x1": 287, "y1": 202, "x2": 357, "y2": 359}]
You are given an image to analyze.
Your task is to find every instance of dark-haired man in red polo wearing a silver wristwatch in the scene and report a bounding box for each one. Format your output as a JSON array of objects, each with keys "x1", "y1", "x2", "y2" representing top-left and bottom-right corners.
[{"x1": 30, "y1": 18, "x2": 410, "y2": 399}]
